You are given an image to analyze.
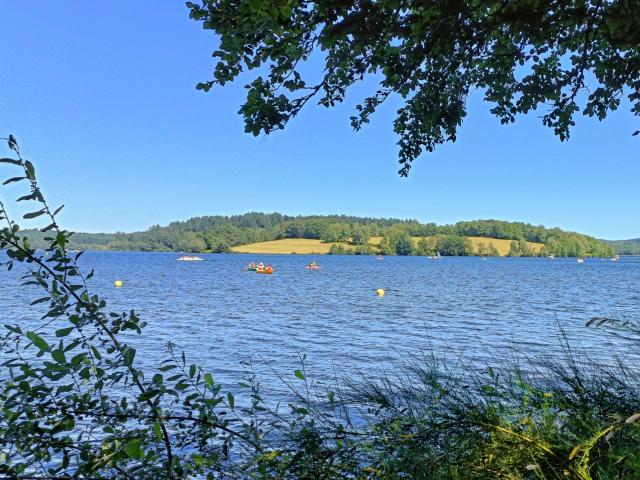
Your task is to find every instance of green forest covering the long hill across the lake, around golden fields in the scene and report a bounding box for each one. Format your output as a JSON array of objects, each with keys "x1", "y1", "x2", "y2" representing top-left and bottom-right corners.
[{"x1": 25, "y1": 212, "x2": 614, "y2": 257}]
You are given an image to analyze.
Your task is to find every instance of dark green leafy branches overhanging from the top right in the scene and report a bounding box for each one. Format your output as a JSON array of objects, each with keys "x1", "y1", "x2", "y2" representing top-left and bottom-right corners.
[{"x1": 187, "y1": 0, "x2": 640, "y2": 176}]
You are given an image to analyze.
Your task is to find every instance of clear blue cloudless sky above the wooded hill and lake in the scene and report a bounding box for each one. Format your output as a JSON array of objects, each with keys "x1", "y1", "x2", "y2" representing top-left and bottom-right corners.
[{"x1": 0, "y1": 0, "x2": 640, "y2": 239}]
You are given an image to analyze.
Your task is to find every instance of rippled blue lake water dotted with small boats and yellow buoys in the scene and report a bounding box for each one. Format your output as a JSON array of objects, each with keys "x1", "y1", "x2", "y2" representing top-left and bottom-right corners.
[{"x1": 0, "y1": 252, "x2": 640, "y2": 396}]
